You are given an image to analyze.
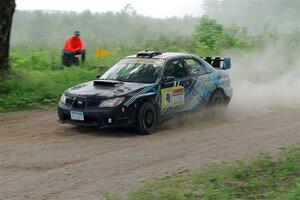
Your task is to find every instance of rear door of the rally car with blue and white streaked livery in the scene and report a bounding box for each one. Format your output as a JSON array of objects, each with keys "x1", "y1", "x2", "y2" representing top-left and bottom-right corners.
[{"x1": 183, "y1": 57, "x2": 216, "y2": 110}]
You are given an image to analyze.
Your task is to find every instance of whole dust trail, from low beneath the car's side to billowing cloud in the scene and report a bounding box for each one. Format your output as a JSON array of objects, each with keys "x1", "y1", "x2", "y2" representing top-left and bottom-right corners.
[{"x1": 162, "y1": 41, "x2": 300, "y2": 130}]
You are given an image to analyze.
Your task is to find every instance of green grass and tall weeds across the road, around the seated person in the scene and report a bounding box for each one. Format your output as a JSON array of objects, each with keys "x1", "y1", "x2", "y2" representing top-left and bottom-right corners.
[{"x1": 0, "y1": 46, "x2": 137, "y2": 112}]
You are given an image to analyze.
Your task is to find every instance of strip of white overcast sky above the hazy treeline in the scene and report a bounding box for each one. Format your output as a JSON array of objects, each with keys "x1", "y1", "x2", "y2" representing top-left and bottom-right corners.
[{"x1": 16, "y1": 0, "x2": 202, "y2": 18}]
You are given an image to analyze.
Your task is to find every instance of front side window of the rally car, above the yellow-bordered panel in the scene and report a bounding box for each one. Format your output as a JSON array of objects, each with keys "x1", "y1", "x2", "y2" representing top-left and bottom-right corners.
[{"x1": 164, "y1": 60, "x2": 188, "y2": 78}]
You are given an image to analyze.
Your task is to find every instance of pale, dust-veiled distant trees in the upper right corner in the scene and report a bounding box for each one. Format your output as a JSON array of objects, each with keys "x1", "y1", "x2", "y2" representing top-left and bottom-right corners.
[{"x1": 202, "y1": 0, "x2": 300, "y2": 34}]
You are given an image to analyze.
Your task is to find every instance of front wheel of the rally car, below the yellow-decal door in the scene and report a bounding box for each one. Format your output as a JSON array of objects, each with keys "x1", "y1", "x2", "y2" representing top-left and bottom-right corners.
[{"x1": 136, "y1": 102, "x2": 157, "y2": 135}]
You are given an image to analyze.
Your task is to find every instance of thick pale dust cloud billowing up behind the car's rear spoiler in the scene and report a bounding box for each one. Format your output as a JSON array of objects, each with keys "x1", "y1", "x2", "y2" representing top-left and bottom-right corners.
[{"x1": 229, "y1": 42, "x2": 300, "y2": 114}]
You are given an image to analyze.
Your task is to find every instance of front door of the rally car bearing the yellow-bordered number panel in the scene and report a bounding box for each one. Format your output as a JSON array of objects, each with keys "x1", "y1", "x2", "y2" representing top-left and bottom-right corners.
[{"x1": 160, "y1": 58, "x2": 192, "y2": 115}]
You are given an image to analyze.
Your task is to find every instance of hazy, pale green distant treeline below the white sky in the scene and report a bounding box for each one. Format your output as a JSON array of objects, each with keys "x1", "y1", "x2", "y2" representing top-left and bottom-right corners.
[{"x1": 11, "y1": 10, "x2": 197, "y2": 48}]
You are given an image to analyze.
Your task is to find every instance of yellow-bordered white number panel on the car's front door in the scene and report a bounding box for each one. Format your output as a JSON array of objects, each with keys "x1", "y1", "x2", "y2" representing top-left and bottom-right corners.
[{"x1": 161, "y1": 86, "x2": 184, "y2": 109}]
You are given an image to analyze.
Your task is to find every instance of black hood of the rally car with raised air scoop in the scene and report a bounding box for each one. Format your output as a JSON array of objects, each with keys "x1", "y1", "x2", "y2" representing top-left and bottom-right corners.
[{"x1": 66, "y1": 80, "x2": 153, "y2": 98}]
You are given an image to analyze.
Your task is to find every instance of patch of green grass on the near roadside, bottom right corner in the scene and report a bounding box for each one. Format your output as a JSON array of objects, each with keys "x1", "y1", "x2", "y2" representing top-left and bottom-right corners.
[{"x1": 104, "y1": 145, "x2": 300, "y2": 200}]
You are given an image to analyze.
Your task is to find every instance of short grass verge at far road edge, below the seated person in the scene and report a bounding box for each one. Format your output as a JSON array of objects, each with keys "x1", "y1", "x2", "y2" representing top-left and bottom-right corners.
[{"x1": 0, "y1": 67, "x2": 104, "y2": 112}]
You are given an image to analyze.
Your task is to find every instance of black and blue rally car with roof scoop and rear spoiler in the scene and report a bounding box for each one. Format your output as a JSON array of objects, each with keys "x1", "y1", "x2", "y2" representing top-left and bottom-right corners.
[{"x1": 57, "y1": 51, "x2": 232, "y2": 134}]
